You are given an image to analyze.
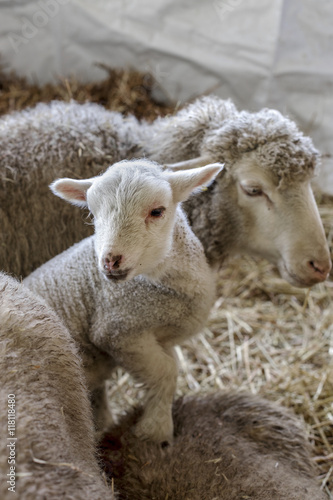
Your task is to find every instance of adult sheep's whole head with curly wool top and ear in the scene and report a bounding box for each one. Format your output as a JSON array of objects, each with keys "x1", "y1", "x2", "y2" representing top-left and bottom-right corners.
[{"x1": 166, "y1": 109, "x2": 331, "y2": 287}]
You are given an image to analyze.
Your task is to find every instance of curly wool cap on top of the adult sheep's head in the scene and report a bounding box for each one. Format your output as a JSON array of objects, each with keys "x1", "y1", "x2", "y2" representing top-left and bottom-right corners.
[{"x1": 202, "y1": 109, "x2": 319, "y2": 188}]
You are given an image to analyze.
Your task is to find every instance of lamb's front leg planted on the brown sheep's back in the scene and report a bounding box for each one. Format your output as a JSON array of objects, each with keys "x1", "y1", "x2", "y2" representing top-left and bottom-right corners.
[{"x1": 117, "y1": 333, "x2": 178, "y2": 444}]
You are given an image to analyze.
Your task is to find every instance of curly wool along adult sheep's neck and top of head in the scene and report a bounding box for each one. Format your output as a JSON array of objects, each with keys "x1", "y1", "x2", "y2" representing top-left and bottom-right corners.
[{"x1": 146, "y1": 96, "x2": 319, "y2": 187}]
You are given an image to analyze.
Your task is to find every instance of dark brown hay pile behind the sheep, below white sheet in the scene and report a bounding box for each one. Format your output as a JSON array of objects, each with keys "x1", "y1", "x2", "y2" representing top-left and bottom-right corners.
[{"x1": 0, "y1": 64, "x2": 174, "y2": 120}]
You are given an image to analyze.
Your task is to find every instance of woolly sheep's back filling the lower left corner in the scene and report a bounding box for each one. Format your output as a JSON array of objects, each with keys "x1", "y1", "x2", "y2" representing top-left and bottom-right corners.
[{"x1": 0, "y1": 273, "x2": 115, "y2": 500}]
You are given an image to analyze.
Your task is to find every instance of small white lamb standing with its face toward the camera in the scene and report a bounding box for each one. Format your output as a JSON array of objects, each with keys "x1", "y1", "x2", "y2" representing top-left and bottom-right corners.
[{"x1": 24, "y1": 160, "x2": 221, "y2": 444}]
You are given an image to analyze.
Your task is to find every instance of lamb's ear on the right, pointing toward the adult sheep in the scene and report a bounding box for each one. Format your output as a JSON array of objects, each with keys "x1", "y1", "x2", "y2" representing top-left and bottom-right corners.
[{"x1": 166, "y1": 163, "x2": 223, "y2": 202}]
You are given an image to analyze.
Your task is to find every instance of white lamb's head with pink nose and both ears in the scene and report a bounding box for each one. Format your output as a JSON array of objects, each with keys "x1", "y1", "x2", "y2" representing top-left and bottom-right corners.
[{"x1": 51, "y1": 160, "x2": 222, "y2": 281}]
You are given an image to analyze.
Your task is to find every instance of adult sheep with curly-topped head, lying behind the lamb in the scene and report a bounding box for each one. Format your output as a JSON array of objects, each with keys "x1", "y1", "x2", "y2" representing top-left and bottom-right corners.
[{"x1": 0, "y1": 96, "x2": 331, "y2": 287}]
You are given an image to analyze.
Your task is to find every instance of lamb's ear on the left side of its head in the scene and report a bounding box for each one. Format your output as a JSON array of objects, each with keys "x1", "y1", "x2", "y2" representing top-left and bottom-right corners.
[{"x1": 50, "y1": 178, "x2": 93, "y2": 208}]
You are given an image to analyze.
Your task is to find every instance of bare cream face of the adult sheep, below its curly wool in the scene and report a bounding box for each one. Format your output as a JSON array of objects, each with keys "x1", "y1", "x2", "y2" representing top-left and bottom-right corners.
[{"x1": 227, "y1": 152, "x2": 331, "y2": 286}]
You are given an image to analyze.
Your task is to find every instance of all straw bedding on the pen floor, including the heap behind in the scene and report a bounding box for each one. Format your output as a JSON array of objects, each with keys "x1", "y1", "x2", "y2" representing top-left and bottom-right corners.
[{"x1": 0, "y1": 65, "x2": 333, "y2": 498}]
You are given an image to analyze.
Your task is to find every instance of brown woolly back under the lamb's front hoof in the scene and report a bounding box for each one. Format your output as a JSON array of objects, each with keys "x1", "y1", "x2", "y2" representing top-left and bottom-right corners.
[{"x1": 100, "y1": 392, "x2": 326, "y2": 500}]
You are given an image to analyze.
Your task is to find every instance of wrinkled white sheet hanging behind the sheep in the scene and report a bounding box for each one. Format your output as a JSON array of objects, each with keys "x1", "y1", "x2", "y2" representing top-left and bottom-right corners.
[{"x1": 0, "y1": 0, "x2": 333, "y2": 193}]
